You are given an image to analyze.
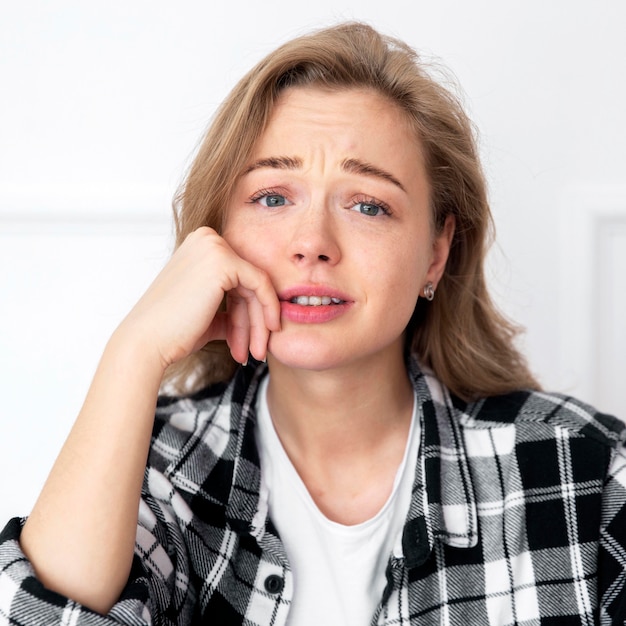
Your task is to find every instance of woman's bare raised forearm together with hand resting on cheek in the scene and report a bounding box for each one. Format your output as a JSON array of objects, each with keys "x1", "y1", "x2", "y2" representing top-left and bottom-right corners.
[{"x1": 21, "y1": 228, "x2": 280, "y2": 613}]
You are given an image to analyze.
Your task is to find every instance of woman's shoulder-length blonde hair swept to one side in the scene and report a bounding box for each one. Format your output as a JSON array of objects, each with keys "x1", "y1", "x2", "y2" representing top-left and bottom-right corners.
[{"x1": 167, "y1": 23, "x2": 538, "y2": 400}]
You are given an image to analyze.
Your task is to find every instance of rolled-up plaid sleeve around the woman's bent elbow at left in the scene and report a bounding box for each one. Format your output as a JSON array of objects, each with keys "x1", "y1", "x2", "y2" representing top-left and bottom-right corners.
[{"x1": 0, "y1": 472, "x2": 195, "y2": 626}]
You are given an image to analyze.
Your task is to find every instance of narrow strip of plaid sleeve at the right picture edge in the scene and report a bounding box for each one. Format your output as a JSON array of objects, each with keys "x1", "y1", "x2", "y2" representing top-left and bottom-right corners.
[{"x1": 598, "y1": 442, "x2": 626, "y2": 626}]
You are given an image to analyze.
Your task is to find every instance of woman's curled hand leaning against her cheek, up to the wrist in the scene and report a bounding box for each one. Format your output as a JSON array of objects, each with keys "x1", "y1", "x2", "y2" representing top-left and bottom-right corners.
[{"x1": 118, "y1": 227, "x2": 280, "y2": 368}]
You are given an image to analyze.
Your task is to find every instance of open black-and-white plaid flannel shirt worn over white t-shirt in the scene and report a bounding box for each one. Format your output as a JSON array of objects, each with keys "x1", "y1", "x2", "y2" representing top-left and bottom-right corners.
[{"x1": 0, "y1": 363, "x2": 626, "y2": 626}]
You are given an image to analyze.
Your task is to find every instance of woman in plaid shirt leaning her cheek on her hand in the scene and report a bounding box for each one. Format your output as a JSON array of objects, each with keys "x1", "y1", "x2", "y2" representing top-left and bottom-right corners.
[{"x1": 0, "y1": 24, "x2": 626, "y2": 626}]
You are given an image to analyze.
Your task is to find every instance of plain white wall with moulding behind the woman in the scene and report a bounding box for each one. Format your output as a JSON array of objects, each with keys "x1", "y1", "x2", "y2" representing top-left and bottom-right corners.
[{"x1": 0, "y1": 0, "x2": 626, "y2": 525}]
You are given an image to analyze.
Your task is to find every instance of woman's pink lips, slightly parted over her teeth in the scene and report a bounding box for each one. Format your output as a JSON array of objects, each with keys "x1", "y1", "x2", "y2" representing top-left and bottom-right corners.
[{"x1": 278, "y1": 285, "x2": 354, "y2": 324}]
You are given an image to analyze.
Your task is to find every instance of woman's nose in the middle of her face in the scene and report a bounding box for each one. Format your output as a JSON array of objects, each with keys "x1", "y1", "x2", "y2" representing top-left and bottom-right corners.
[{"x1": 290, "y1": 206, "x2": 341, "y2": 265}]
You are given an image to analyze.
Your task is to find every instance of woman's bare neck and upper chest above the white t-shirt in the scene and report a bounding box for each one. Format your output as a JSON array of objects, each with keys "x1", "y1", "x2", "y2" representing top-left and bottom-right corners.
[{"x1": 267, "y1": 357, "x2": 413, "y2": 524}]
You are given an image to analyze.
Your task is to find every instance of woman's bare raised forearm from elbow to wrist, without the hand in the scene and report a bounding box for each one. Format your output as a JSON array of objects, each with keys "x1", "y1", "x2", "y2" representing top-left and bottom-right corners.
[{"x1": 21, "y1": 330, "x2": 163, "y2": 613}]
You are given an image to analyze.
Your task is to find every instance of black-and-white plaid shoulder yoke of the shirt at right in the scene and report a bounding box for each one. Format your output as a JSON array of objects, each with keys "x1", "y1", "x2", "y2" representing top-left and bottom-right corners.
[{"x1": 455, "y1": 390, "x2": 626, "y2": 448}]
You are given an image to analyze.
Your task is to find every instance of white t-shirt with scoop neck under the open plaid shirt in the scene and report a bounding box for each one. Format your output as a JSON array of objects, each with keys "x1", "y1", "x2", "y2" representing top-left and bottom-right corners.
[{"x1": 256, "y1": 377, "x2": 419, "y2": 626}]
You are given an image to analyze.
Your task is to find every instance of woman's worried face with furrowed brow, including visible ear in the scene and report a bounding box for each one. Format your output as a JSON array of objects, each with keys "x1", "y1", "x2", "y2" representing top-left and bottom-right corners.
[{"x1": 223, "y1": 88, "x2": 453, "y2": 370}]
